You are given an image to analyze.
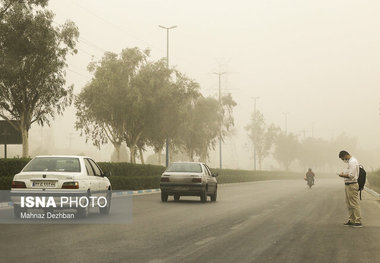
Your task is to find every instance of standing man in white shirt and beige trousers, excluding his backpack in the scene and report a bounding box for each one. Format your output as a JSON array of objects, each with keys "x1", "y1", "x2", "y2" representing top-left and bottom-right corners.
[{"x1": 339, "y1": 151, "x2": 362, "y2": 227}]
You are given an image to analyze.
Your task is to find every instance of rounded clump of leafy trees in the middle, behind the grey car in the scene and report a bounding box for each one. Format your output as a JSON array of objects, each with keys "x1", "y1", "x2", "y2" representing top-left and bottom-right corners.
[{"x1": 75, "y1": 48, "x2": 236, "y2": 163}]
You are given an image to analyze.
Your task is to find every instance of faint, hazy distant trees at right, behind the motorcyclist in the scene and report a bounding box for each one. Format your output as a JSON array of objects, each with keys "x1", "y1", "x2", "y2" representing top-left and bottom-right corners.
[{"x1": 246, "y1": 111, "x2": 360, "y2": 171}]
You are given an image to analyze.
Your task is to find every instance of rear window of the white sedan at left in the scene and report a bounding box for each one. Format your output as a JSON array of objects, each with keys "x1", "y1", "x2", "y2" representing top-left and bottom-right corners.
[{"x1": 23, "y1": 157, "x2": 80, "y2": 172}]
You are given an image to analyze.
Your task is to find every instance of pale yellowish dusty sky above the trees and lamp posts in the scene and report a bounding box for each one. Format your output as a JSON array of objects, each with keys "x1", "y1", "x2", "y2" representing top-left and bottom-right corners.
[{"x1": 21, "y1": 0, "x2": 380, "y2": 168}]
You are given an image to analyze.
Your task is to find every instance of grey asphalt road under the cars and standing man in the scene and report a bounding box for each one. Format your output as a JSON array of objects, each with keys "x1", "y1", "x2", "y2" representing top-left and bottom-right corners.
[{"x1": 0, "y1": 178, "x2": 380, "y2": 263}]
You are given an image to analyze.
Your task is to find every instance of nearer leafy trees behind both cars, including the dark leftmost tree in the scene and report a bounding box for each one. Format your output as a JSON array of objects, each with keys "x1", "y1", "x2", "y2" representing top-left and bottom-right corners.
[{"x1": 0, "y1": 0, "x2": 236, "y2": 163}]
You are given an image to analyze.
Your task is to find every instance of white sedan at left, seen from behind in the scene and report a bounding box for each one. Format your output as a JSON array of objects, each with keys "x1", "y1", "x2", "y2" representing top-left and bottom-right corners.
[{"x1": 11, "y1": 155, "x2": 112, "y2": 217}]
